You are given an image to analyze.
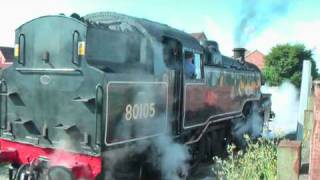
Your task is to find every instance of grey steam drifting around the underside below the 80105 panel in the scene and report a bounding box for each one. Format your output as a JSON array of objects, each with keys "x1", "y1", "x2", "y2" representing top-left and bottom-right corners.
[{"x1": 104, "y1": 131, "x2": 190, "y2": 180}]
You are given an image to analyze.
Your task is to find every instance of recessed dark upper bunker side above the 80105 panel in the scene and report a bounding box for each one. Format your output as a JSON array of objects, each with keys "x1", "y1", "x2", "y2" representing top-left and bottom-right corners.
[{"x1": 86, "y1": 28, "x2": 153, "y2": 73}]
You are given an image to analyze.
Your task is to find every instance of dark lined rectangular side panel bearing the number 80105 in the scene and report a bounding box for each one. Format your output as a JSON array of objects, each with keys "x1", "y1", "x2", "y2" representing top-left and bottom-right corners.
[{"x1": 105, "y1": 81, "x2": 168, "y2": 146}]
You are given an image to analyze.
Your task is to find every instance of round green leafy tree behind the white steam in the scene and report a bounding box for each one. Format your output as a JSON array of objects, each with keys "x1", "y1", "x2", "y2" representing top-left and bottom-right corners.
[{"x1": 263, "y1": 44, "x2": 318, "y2": 87}]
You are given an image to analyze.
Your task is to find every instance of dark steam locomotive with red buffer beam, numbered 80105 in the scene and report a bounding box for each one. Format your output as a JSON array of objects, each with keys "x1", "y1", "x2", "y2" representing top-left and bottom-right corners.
[{"x1": 0, "y1": 12, "x2": 270, "y2": 180}]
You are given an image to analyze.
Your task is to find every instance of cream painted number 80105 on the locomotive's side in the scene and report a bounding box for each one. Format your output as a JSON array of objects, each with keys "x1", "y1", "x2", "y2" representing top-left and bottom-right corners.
[{"x1": 125, "y1": 103, "x2": 156, "y2": 121}]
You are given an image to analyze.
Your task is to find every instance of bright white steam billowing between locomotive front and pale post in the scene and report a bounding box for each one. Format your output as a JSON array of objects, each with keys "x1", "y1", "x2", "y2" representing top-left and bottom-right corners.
[{"x1": 261, "y1": 82, "x2": 299, "y2": 137}]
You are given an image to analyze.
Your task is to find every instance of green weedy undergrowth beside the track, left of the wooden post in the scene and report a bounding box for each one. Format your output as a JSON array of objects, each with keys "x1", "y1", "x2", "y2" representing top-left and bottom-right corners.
[{"x1": 213, "y1": 135, "x2": 277, "y2": 180}]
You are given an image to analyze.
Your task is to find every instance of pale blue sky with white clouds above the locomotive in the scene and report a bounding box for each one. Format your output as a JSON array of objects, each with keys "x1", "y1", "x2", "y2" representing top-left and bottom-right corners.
[{"x1": 0, "y1": 0, "x2": 320, "y2": 61}]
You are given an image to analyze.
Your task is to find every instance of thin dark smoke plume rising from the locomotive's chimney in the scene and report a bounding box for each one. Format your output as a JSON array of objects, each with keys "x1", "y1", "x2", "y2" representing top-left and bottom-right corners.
[{"x1": 234, "y1": 0, "x2": 293, "y2": 47}]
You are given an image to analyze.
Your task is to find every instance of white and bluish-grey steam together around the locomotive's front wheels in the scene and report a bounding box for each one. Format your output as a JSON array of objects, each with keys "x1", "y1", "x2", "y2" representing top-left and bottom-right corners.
[{"x1": 232, "y1": 82, "x2": 299, "y2": 145}]
